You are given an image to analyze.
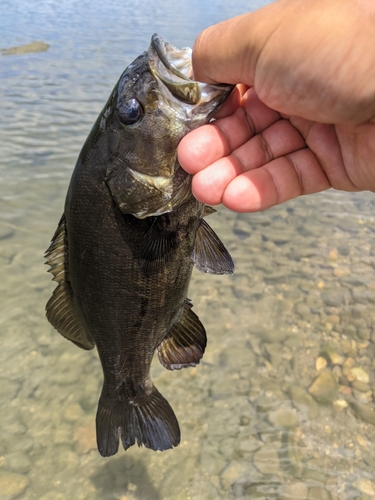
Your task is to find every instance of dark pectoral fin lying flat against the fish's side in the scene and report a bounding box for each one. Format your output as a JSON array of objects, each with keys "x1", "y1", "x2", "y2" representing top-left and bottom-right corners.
[{"x1": 139, "y1": 218, "x2": 178, "y2": 271}]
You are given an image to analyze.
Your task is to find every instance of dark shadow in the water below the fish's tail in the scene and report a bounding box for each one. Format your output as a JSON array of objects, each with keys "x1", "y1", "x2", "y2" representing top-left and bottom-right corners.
[{"x1": 91, "y1": 456, "x2": 161, "y2": 500}]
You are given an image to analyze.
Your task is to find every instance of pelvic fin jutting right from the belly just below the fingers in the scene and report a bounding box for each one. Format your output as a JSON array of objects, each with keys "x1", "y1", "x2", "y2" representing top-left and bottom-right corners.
[{"x1": 191, "y1": 219, "x2": 234, "y2": 274}]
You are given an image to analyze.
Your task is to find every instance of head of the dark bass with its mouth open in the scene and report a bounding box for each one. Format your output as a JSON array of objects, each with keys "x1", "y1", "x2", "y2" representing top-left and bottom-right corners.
[{"x1": 97, "y1": 34, "x2": 233, "y2": 218}]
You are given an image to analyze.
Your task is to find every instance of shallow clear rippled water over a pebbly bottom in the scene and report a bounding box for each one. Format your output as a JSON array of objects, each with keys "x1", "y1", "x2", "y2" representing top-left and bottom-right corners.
[{"x1": 0, "y1": 0, "x2": 375, "y2": 500}]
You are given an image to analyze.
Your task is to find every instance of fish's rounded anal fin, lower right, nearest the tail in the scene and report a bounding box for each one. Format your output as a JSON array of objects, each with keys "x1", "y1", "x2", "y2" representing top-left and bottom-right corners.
[{"x1": 158, "y1": 299, "x2": 207, "y2": 370}]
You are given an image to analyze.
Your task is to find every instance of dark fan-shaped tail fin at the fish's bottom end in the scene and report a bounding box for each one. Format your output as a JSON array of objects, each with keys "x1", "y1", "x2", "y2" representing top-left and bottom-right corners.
[{"x1": 96, "y1": 387, "x2": 180, "y2": 457}]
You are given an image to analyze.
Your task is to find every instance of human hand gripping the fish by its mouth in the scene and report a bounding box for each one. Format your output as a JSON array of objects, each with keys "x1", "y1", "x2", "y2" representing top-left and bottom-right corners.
[{"x1": 178, "y1": 0, "x2": 375, "y2": 212}]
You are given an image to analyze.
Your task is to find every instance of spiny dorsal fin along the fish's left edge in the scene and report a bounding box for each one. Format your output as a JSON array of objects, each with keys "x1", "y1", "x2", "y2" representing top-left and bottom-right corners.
[{"x1": 45, "y1": 215, "x2": 95, "y2": 350}]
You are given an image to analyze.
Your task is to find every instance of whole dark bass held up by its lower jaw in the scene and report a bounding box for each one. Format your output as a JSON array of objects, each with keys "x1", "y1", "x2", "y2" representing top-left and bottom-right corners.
[{"x1": 45, "y1": 34, "x2": 234, "y2": 457}]
